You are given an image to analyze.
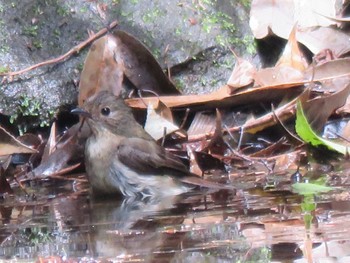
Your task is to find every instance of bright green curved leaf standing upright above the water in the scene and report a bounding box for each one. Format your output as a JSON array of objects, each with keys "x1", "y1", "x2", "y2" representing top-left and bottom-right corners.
[{"x1": 295, "y1": 101, "x2": 349, "y2": 155}]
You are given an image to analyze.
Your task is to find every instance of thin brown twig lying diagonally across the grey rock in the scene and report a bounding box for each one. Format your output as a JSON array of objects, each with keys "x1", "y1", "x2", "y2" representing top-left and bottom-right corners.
[{"x1": 0, "y1": 21, "x2": 118, "y2": 78}]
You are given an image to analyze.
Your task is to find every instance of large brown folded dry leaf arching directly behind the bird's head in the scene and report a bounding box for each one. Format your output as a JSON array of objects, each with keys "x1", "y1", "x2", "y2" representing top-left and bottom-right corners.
[{"x1": 79, "y1": 31, "x2": 179, "y2": 106}]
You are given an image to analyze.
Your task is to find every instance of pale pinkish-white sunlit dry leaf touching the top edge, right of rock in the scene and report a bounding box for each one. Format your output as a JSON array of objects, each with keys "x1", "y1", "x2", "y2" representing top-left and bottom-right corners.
[{"x1": 249, "y1": 0, "x2": 336, "y2": 39}]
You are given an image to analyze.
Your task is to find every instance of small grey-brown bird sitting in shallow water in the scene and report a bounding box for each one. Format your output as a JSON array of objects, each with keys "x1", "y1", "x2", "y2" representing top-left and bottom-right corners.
[{"x1": 72, "y1": 91, "x2": 227, "y2": 197}]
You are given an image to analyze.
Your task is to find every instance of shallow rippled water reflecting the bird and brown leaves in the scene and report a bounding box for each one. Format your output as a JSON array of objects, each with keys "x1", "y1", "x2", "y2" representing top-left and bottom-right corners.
[{"x1": 0, "y1": 170, "x2": 350, "y2": 262}]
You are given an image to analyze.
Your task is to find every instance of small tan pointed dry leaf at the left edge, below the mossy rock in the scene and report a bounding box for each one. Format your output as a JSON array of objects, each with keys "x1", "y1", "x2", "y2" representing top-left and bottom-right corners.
[{"x1": 0, "y1": 127, "x2": 36, "y2": 156}]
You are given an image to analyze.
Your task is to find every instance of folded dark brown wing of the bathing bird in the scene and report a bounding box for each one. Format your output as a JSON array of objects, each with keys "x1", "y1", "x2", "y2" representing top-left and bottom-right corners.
[{"x1": 116, "y1": 138, "x2": 188, "y2": 176}]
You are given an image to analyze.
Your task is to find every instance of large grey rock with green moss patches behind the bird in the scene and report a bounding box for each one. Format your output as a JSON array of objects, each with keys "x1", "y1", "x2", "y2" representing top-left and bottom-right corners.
[{"x1": 0, "y1": 0, "x2": 255, "y2": 131}]
